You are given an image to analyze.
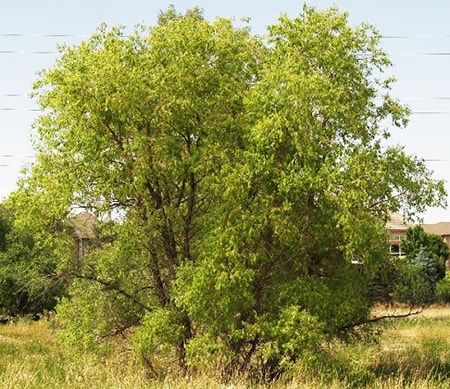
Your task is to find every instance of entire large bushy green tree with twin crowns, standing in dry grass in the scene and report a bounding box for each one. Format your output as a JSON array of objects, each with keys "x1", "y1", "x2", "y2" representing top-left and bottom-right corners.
[{"x1": 8, "y1": 6, "x2": 445, "y2": 378}]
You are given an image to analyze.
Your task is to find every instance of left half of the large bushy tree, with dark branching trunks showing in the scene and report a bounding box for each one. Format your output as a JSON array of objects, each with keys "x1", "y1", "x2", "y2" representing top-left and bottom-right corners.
[{"x1": 13, "y1": 8, "x2": 264, "y2": 366}]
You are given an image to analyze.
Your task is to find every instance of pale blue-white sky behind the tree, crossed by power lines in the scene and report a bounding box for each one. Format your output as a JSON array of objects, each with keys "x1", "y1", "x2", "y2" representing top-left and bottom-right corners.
[{"x1": 0, "y1": 0, "x2": 450, "y2": 223}]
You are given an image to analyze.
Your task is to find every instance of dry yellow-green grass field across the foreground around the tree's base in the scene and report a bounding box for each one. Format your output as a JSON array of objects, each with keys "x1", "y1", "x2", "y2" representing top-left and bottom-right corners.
[{"x1": 0, "y1": 307, "x2": 450, "y2": 389}]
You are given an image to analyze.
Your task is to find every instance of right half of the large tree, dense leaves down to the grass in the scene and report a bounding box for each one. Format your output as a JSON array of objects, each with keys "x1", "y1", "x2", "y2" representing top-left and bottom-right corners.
[{"x1": 178, "y1": 8, "x2": 442, "y2": 376}]
